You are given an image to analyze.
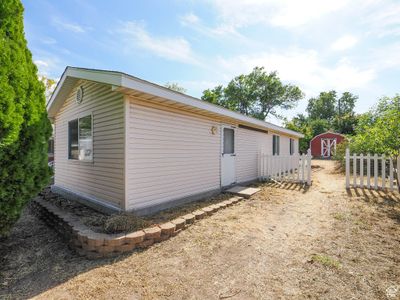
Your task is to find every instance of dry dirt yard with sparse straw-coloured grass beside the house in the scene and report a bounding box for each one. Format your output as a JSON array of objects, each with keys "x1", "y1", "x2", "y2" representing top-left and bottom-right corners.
[{"x1": 0, "y1": 160, "x2": 400, "y2": 299}]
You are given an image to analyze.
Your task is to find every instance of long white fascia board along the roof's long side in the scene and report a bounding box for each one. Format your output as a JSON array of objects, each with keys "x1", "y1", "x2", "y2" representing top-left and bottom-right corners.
[{"x1": 122, "y1": 74, "x2": 304, "y2": 138}]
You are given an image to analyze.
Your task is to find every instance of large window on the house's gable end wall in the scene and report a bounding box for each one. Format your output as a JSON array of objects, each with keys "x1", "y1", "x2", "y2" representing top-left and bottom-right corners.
[{"x1": 68, "y1": 115, "x2": 93, "y2": 161}]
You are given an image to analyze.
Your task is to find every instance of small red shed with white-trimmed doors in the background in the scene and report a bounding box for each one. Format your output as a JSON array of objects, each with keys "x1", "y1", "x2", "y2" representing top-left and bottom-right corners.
[{"x1": 310, "y1": 131, "x2": 345, "y2": 158}]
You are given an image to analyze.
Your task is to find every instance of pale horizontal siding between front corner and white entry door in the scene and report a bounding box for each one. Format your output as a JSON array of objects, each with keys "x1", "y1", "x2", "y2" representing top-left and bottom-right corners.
[{"x1": 127, "y1": 98, "x2": 220, "y2": 209}]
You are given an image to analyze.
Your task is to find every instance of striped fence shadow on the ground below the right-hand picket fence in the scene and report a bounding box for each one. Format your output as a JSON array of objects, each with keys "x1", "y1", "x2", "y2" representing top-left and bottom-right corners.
[{"x1": 346, "y1": 188, "x2": 400, "y2": 224}]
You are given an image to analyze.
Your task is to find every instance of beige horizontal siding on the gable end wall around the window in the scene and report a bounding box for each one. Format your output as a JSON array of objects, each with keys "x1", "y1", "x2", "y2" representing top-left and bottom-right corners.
[{"x1": 55, "y1": 82, "x2": 125, "y2": 208}]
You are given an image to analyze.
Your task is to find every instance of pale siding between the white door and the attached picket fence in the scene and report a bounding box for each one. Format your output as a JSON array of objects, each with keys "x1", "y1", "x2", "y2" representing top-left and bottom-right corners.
[{"x1": 236, "y1": 128, "x2": 272, "y2": 182}]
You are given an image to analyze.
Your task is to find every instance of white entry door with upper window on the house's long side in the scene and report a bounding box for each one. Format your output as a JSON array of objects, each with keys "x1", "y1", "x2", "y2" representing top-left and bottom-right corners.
[{"x1": 221, "y1": 126, "x2": 236, "y2": 187}]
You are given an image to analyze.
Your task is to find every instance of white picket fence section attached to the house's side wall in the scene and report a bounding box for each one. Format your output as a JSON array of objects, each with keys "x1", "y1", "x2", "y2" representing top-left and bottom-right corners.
[{"x1": 259, "y1": 149, "x2": 311, "y2": 185}]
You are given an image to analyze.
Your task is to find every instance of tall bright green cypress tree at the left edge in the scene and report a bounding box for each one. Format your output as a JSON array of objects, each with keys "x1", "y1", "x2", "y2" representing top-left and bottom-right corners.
[{"x1": 0, "y1": 0, "x2": 51, "y2": 236}]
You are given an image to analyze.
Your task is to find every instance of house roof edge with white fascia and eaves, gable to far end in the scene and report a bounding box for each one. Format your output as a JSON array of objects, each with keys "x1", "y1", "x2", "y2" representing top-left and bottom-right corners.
[{"x1": 47, "y1": 67, "x2": 304, "y2": 138}]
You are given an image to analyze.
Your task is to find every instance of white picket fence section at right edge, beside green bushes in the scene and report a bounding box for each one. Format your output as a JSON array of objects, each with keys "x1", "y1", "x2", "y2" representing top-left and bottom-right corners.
[{"x1": 345, "y1": 149, "x2": 400, "y2": 191}]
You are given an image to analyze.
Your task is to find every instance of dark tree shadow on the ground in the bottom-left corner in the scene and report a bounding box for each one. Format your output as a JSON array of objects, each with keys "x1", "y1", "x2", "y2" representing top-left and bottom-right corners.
[{"x1": 0, "y1": 207, "x2": 131, "y2": 299}]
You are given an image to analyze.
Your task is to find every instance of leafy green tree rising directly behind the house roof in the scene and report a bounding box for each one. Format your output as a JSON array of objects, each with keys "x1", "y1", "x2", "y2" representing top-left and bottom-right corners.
[{"x1": 201, "y1": 67, "x2": 304, "y2": 120}]
